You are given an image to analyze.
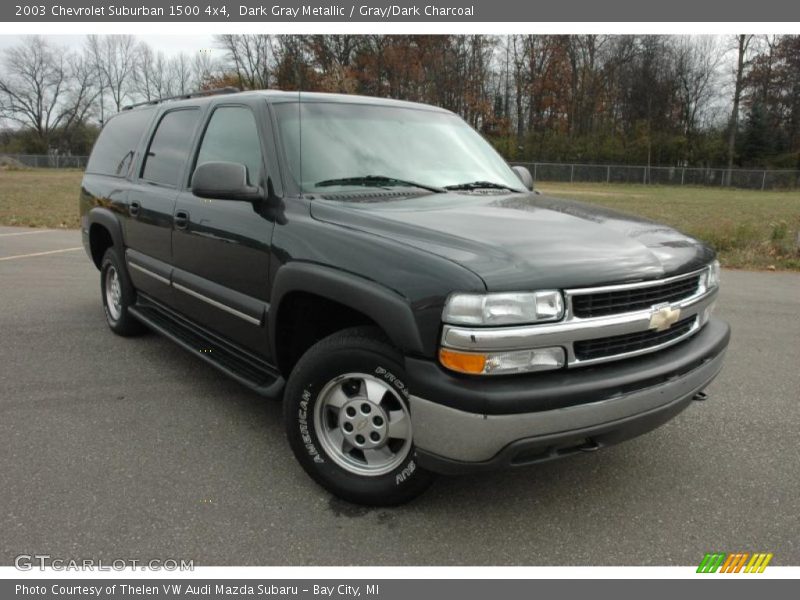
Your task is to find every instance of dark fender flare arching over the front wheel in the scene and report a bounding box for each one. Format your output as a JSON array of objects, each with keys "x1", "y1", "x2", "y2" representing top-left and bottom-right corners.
[{"x1": 268, "y1": 262, "x2": 423, "y2": 360}]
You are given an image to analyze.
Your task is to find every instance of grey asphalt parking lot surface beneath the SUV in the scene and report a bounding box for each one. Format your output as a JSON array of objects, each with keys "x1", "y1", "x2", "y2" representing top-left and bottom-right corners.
[{"x1": 0, "y1": 227, "x2": 800, "y2": 565}]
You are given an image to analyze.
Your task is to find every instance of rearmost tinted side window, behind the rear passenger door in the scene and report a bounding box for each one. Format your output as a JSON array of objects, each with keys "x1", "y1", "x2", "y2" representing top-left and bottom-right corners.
[{"x1": 86, "y1": 110, "x2": 153, "y2": 177}]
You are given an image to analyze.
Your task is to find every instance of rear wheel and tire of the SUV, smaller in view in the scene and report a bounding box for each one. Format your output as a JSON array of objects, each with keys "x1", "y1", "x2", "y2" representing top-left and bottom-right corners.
[{"x1": 100, "y1": 246, "x2": 146, "y2": 337}]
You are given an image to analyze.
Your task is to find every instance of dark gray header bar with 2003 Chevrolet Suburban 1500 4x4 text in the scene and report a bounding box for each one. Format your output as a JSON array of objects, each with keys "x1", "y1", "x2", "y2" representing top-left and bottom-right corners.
[{"x1": 0, "y1": 0, "x2": 800, "y2": 23}]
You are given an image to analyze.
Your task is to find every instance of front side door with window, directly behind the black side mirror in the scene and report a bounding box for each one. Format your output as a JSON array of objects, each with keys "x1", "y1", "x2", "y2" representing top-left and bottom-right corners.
[{"x1": 172, "y1": 103, "x2": 274, "y2": 357}]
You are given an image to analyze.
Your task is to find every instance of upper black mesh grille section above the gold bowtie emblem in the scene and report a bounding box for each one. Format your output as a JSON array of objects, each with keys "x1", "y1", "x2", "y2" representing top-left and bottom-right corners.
[{"x1": 572, "y1": 275, "x2": 700, "y2": 319}]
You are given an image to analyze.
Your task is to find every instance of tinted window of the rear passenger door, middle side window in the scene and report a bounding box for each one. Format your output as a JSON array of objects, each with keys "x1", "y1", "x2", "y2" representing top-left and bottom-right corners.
[{"x1": 142, "y1": 110, "x2": 200, "y2": 186}]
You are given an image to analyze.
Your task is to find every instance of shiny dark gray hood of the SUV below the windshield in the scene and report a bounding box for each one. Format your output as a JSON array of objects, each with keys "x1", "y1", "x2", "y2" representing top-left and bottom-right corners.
[{"x1": 311, "y1": 193, "x2": 714, "y2": 291}]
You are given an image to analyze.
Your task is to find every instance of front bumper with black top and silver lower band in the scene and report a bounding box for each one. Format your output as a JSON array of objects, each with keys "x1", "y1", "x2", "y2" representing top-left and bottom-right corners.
[{"x1": 406, "y1": 319, "x2": 730, "y2": 473}]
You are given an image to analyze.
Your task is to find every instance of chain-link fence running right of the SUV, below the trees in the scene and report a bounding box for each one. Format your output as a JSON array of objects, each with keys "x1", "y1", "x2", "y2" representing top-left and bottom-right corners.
[{"x1": 512, "y1": 162, "x2": 800, "y2": 190}]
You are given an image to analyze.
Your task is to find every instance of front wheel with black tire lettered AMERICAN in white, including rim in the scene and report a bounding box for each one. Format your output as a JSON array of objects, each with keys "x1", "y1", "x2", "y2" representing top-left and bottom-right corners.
[{"x1": 284, "y1": 327, "x2": 434, "y2": 506}]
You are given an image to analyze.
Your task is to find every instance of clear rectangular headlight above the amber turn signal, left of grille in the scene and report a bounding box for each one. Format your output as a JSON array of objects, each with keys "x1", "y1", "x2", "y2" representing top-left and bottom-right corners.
[{"x1": 442, "y1": 290, "x2": 564, "y2": 325}]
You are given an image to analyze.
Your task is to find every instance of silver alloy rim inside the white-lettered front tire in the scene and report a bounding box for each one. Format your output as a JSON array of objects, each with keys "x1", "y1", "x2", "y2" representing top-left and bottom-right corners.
[{"x1": 314, "y1": 373, "x2": 411, "y2": 476}]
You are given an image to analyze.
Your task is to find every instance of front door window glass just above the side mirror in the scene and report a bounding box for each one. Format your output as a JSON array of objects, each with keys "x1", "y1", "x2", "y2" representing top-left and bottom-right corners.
[{"x1": 196, "y1": 106, "x2": 263, "y2": 185}]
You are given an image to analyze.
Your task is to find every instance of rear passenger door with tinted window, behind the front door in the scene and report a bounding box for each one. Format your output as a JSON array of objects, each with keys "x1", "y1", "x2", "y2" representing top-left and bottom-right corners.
[{"x1": 125, "y1": 107, "x2": 201, "y2": 301}]
